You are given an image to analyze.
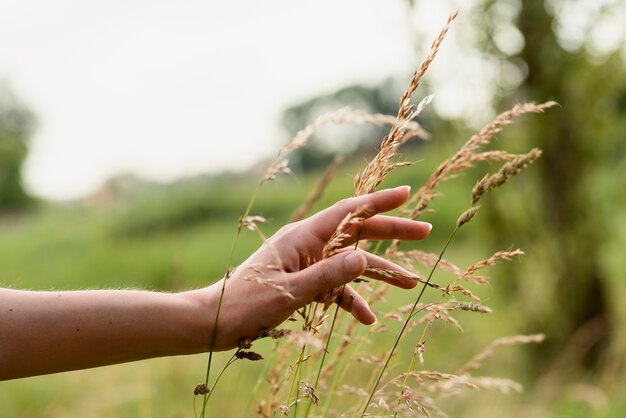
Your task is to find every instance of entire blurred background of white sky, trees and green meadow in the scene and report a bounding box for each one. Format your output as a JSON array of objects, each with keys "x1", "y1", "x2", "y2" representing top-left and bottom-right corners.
[{"x1": 0, "y1": 0, "x2": 626, "y2": 417}]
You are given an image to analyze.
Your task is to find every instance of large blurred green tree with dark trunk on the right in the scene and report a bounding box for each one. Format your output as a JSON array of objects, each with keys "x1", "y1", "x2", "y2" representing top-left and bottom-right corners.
[{"x1": 466, "y1": 0, "x2": 626, "y2": 366}]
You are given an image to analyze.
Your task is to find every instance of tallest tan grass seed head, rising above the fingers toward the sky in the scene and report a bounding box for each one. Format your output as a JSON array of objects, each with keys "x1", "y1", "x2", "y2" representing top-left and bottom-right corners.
[{"x1": 354, "y1": 12, "x2": 458, "y2": 196}]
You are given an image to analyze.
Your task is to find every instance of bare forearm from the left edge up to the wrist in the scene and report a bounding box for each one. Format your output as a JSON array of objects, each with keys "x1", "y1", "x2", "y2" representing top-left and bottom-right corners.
[{"x1": 0, "y1": 289, "x2": 212, "y2": 380}]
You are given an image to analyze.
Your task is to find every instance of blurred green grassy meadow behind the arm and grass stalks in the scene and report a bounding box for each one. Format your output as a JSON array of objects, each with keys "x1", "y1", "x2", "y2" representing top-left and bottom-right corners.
[{"x1": 0, "y1": 135, "x2": 626, "y2": 417}]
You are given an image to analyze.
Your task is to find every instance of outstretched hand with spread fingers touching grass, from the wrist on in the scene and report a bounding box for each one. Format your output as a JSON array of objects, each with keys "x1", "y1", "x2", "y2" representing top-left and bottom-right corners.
[{"x1": 190, "y1": 186, "x2": 431, "y2": 350}]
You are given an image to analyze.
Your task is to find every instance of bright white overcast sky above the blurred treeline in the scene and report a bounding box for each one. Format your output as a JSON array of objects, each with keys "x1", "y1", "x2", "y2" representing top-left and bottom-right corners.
[{"x1": 0, "y1": 0, "x2": 428, "y2": 198}]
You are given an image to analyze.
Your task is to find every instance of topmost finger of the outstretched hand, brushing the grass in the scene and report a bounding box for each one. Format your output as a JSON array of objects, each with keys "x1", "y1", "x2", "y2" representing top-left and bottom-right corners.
[{"x1": 308, "y1": 186, "x2": 411, "y2": 239}]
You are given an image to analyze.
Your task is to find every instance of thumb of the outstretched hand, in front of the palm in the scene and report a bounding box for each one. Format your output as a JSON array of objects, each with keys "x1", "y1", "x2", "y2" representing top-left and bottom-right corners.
[{"x1": 291, "y1": 251, "x2": 367, "y2": 301}]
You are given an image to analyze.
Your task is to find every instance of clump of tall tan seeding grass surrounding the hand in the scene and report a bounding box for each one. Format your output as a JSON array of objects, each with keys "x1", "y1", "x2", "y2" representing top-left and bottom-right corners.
[{"x1": 196, "y1": 13, "x2": 555, "y2": 417}]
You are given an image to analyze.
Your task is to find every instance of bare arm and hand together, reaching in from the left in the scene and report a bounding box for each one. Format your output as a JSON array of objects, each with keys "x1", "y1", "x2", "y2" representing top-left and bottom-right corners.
[{"x1": 0, "y1": 186, "x2": 431, "y2": 380}]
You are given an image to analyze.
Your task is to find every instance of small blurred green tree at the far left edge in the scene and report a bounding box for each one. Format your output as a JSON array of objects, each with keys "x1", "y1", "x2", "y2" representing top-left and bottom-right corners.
[{"x1": 0, "y1": 84, "x2": 35, "y2": 213}]
